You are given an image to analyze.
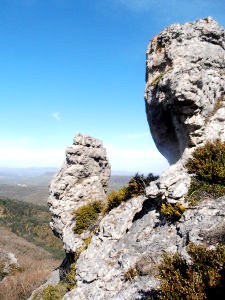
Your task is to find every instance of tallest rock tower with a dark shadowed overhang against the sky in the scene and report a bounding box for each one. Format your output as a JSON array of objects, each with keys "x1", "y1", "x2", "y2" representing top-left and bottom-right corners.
[{"x1": 145, "y1": 17, "x2": 225, "y2": 164}]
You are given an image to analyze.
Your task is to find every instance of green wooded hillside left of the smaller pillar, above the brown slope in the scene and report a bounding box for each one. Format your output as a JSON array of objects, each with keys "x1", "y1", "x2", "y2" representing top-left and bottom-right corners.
[{"x1": 0, "y1": 199, "x2": 64, "y2": 258}]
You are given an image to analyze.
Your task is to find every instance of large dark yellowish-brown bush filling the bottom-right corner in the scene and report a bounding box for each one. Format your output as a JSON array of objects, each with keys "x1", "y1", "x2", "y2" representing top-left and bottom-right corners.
[{"x1": 159, "y1": 244, "x2": 225, "y2": 300}]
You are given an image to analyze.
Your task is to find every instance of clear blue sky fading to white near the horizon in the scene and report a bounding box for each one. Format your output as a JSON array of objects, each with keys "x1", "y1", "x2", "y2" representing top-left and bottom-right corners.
[{"x1": 0, "y1": 0, "x2": 225, "y2": 174}]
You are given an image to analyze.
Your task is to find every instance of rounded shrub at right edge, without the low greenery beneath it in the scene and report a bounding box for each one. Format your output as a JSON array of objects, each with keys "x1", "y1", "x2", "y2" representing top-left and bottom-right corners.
[{"x1": 186, "y1": 140, "x2": 225, "y2": 184}]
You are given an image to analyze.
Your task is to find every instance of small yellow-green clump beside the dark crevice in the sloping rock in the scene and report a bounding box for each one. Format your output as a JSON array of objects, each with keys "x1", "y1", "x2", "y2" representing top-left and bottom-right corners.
[{"x1": 160, "y1": 202, "x2": 186, "y2": 222}]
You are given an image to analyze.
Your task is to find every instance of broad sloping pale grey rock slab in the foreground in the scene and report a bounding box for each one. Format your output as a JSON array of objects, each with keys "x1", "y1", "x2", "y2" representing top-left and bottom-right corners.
[{"x1": 63, "y1": 197, "x2": 225, "y2": 300}]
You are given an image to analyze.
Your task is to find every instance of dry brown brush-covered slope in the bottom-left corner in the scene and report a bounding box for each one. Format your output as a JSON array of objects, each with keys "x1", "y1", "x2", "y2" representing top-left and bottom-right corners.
[{"x1": 0, "y1": 227, "x2": 61, "y2": 300}]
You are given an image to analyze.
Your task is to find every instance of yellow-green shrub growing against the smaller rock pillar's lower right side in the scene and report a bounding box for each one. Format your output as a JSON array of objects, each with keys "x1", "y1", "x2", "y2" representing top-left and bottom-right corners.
[{"x1": 73, "y1": 201, "x2": 103, "y2": 234}]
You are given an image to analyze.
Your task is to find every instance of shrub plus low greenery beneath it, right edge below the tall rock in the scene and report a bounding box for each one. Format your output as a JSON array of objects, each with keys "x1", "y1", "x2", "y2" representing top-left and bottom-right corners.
[{"x1": 186, "y1": 140, "x2": 225, "y2": 204}]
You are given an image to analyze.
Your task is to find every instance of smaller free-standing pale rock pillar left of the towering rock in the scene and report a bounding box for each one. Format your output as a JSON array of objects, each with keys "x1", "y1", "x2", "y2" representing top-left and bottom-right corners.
[{"x1": 48, "y1": 134, "x2": 110, "y2": 253}]
